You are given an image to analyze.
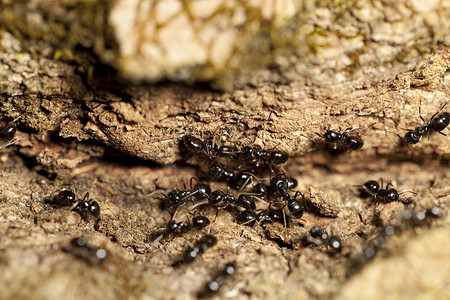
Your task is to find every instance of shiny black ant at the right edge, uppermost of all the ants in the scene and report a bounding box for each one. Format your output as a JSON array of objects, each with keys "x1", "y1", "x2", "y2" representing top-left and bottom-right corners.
[{"x1": 397, "y1": 100, "x2": 450, "y2": 144}]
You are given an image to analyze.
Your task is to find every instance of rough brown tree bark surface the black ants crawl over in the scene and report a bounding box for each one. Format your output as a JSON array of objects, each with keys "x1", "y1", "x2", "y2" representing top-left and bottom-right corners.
[{"x1": 0, "y1": 0, "x2": 450, "y2": 299}]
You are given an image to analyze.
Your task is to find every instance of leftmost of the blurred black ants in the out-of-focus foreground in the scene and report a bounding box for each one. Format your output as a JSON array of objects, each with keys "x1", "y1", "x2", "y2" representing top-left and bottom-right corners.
[{"x1": 62, "y1": 237, "x2": 108, "y2": 264}]
